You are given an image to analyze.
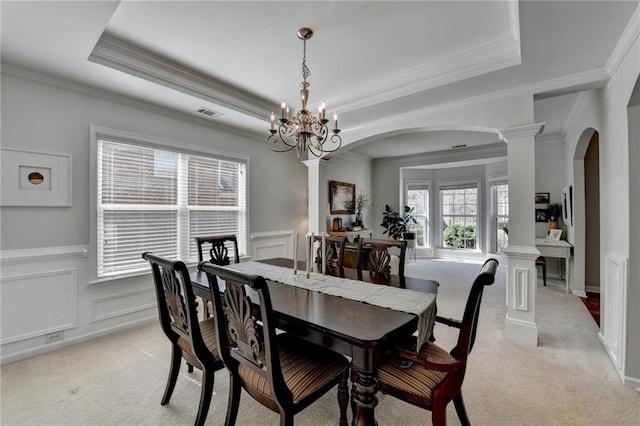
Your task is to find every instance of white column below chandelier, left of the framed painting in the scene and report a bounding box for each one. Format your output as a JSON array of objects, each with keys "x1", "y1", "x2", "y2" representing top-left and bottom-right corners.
[{"x1": 303, "y1": 158, "x2": 329, "y2": 234}]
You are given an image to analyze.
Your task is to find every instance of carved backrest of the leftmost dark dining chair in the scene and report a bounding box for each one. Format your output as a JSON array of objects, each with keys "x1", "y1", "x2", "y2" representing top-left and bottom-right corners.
[{"x1": 142, "y1": 252, "x2": 213, "y2": 363}]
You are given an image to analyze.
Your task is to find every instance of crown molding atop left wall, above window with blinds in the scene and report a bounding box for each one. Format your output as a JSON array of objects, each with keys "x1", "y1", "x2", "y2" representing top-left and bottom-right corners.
[{"x1": 1, "y1": 64, "x2": 262, "y2": 140}]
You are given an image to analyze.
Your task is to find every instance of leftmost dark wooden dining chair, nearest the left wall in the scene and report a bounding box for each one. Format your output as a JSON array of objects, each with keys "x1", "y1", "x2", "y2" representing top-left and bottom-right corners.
[{"x1": 142, "y1": 253, "x2": 224, "y2": 425}]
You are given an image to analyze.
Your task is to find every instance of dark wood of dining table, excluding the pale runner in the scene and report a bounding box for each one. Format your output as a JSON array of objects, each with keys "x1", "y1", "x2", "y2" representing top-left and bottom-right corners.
[{"x1": 191, "y1": 258, "x2": 438, "y2": 426}]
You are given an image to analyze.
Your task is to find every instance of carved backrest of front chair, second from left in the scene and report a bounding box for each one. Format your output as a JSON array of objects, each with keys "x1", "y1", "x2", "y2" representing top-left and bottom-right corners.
[{"x1": 198, "y1": 262, "x2": 293, "y2": 402}]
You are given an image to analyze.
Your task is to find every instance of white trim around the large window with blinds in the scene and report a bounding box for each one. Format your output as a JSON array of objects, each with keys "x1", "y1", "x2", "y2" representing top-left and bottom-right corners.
[{"x1": 89, "y1": 124, "x2": 251, "y2": 284}]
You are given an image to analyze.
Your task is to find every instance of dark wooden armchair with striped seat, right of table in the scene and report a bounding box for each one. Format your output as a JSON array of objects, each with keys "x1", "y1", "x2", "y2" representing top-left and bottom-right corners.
[{"x1": 376, "y1": 259, "x2": 498, "y2": 426}]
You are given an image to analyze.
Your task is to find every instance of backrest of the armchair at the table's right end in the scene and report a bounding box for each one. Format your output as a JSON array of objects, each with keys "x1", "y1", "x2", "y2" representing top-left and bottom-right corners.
[{"x1": 451, "y1": 258, "x2": 498, "y2": 359}]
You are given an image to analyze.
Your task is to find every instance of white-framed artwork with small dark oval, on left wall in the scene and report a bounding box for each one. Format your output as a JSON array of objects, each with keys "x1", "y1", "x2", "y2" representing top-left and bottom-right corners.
[{"x1": 0, "y1": 148, "x2": 71, "y2": 207}]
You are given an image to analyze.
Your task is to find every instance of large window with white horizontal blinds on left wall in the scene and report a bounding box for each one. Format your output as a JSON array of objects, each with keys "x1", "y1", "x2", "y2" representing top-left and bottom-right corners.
[{"x1": 96, "y1": 135, "x2": 246, "y2": 278}]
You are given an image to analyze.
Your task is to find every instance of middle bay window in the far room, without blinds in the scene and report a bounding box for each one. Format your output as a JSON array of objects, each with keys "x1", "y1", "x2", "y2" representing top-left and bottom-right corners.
[{"x1": 439, "y1": 182, "x2": 478, "y2": 249}]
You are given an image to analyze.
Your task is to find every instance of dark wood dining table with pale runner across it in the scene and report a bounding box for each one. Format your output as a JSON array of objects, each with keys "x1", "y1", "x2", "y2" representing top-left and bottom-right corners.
[{"x1": 190, "y1": 258, "x2": 439, "y2": 426}]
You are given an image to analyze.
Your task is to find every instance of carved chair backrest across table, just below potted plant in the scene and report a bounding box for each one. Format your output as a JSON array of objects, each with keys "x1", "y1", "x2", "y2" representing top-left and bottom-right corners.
[{"x1": 356, "y1": 238, "x2": 407, "y2": 277}]
